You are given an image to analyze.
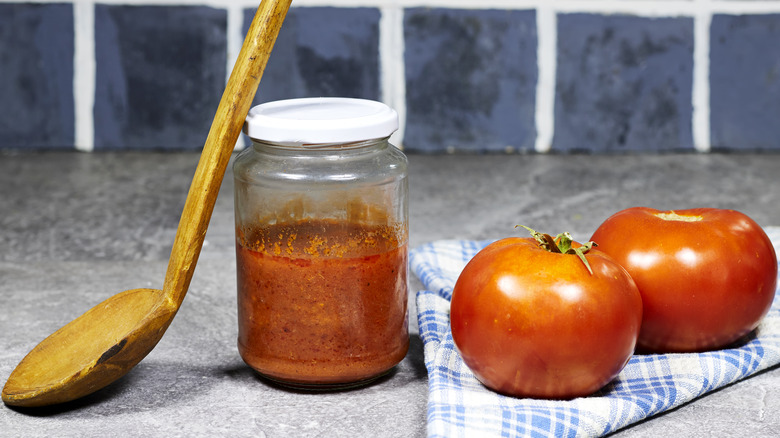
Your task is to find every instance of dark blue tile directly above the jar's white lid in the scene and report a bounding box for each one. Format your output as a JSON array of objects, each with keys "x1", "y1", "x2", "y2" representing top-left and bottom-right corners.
[{"x1": 250, "y1": 7, "x2": 380, "y2": 102}]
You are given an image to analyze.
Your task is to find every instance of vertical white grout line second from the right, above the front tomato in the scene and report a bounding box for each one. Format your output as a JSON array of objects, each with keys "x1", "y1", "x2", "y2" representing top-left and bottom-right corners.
[{"x1": 534, "y1": 6, "x2": 558, "y2": 153}]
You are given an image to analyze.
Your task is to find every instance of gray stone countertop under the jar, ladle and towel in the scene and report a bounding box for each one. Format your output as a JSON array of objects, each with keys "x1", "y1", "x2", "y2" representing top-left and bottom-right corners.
[{"x1": 0, "y1": 152, "x2": 780, "y2": 437}]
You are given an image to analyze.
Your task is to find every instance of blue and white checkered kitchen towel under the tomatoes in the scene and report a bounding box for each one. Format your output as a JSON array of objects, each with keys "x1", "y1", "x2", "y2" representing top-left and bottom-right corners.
[{"x1": 410, "y1": 228, "x2": 780, "y2": 437}]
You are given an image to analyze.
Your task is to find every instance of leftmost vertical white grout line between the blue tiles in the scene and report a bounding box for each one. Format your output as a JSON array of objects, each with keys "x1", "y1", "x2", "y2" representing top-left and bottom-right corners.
[{"x1": 73, "y1": 1, "x2": 96, "y2": 152}]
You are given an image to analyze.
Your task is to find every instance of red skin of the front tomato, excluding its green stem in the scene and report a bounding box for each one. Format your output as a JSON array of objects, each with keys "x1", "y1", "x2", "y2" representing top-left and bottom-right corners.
[{"x1": 450, "y1": 238, "x2": 642, "y2": 399}]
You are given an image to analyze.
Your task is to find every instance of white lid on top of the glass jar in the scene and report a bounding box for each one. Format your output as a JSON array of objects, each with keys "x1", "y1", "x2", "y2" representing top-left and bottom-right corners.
[{"x1": 244, "y1": 97, "x2": 398, "y2": 145}]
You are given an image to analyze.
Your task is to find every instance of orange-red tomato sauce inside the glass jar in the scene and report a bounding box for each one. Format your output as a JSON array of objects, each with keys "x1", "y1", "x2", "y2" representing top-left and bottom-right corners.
[{"x1": 236, "y1": 220, "x2": 409, "y2": 387}]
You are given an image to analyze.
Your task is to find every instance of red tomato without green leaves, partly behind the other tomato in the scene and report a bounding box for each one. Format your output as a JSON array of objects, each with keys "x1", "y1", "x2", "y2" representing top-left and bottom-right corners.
[{"x1": 591, "y1": 207, "x2": 777, "y2": 352}]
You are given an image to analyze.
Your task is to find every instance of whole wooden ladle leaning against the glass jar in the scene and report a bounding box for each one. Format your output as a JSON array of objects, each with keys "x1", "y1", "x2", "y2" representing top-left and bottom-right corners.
[{"x1": 2, "y1": 0, "x2": 292, "y2": 407}]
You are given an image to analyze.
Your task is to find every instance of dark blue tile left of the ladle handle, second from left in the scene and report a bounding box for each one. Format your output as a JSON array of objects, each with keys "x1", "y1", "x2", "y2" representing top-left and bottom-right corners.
[{"x1": 95, "y1": 4, "x2": 227, "y2": 149}]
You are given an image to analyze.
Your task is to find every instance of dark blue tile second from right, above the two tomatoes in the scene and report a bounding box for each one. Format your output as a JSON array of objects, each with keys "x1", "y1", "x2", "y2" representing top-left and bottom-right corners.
[{"x1": 553, "y1": 14, "x2": 693, "y2": 152}]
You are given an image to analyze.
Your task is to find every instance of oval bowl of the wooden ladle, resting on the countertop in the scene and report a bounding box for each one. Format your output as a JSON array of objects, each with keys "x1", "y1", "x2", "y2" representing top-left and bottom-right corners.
[{"x1": 3, "y1": 289, "x2": 177, "y2": 407}]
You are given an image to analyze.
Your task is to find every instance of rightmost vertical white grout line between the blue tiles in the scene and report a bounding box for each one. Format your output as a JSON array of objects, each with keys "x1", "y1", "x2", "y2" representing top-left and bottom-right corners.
[{"x1": 691, "y1": 0, "x2": 712, "y2": 152}]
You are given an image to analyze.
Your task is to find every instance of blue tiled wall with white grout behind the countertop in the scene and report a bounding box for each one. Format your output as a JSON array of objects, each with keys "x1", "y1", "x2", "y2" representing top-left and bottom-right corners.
[{"x1": 0, "y1": 0, "x2": 780, "y2": 154}]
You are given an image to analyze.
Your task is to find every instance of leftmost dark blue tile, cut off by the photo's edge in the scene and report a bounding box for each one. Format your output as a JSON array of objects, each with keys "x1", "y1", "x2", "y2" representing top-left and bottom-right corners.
[{"x1": 0, "y1": 3, "x2": 75, "y2": 149}]
